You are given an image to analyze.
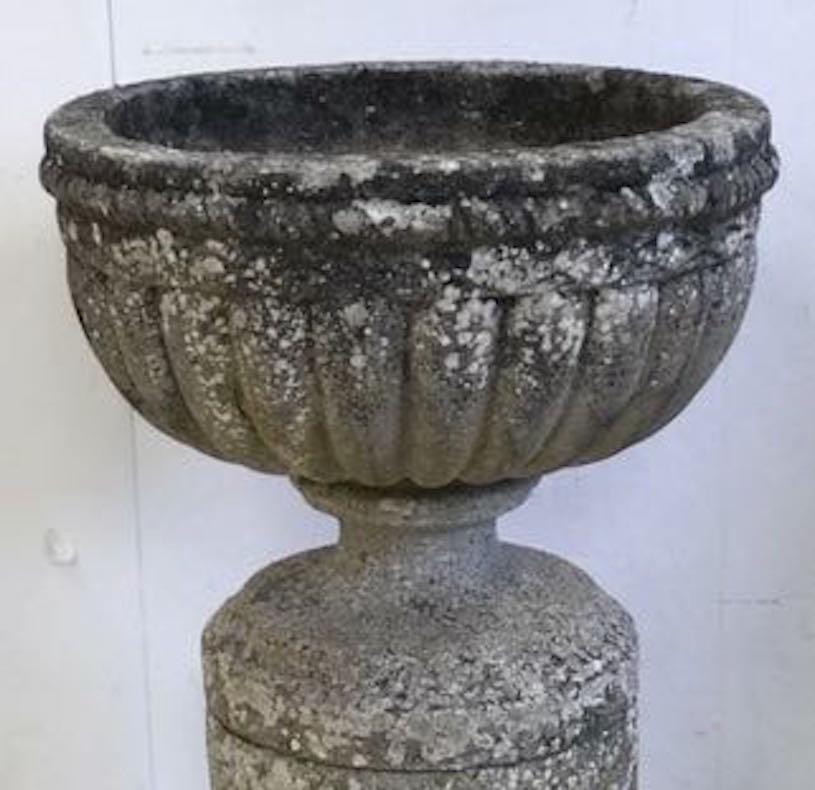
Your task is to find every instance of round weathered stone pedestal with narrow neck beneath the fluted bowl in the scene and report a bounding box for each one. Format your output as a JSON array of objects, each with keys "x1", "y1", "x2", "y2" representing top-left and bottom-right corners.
[{"x1": 204, "y1": 483, "x2": 637, "y2": 790}]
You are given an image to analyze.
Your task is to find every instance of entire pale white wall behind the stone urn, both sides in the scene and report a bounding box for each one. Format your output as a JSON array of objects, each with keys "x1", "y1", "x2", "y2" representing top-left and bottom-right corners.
[{"x1": 0, "y1": 0, "x2": 815, "y2": 790}]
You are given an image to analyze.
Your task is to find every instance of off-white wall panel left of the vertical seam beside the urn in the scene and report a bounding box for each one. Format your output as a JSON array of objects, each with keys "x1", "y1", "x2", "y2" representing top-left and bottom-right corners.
[{"x1": 0, "y1": 0, "x2": 148, "y2": 790}]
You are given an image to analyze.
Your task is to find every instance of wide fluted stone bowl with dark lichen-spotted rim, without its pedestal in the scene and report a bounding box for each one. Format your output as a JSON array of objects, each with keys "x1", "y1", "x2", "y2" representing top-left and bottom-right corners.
[{"x1": 41, "y1": 63, "x2": 777, "y2": 487}]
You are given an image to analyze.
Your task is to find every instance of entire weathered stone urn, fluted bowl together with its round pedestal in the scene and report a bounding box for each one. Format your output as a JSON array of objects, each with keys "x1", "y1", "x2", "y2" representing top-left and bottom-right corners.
[{"x1": 41, "y1": 63, "x2": 778, "y2": 790}]
